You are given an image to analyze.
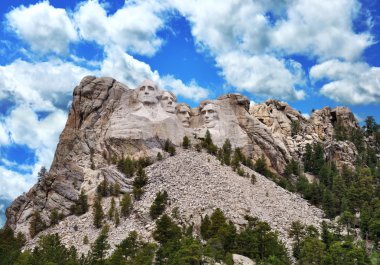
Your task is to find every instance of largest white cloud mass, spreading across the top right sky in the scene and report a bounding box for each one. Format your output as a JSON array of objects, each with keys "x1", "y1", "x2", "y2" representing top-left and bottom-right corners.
[{"x1": 169, "y1": 0, "x2": 373, "y2": 99}]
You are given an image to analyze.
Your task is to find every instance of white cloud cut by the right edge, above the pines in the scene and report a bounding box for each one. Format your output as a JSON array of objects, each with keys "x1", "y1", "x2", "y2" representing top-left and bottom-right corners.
[{"x1": 310, "y1": 60, "x2": 380, "y2": 104}]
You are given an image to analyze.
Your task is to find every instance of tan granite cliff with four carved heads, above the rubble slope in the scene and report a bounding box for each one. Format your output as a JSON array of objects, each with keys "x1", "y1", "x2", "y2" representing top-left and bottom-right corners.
[{"x1": 6, "y1": 76, "x2": 358, "y2": 241}]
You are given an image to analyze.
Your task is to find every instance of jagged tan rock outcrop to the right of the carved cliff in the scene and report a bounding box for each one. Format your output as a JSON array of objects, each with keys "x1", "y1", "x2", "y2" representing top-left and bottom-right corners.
[{"x1": 249, "y1": 99, "x2": 359, "y2": 167}]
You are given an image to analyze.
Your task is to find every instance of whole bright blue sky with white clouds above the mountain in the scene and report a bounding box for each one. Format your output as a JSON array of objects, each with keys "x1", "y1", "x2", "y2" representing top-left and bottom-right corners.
[{"x1": 0, "y1": 0, "x2": 380, "y2": 223}]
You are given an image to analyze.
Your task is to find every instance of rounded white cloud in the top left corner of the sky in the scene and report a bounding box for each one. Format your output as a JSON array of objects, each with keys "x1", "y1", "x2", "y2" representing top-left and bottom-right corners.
[{"x1": 6, "y1": 1, "x2": 77, "y2": 53}]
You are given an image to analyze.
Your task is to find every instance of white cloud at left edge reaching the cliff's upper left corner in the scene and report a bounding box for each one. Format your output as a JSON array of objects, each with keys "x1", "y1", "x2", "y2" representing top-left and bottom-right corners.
[{"x1": 0, "y1": 59, "x2": 91, "y2": 111}]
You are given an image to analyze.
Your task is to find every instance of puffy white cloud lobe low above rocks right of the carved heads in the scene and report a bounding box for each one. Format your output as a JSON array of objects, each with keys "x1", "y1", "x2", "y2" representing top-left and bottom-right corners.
[{"x1": 217, "y1": 52, "x2": 305, "y2": 100}]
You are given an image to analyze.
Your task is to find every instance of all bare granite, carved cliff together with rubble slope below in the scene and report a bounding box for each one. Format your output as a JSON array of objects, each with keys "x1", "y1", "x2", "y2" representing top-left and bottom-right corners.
[{"x1": 7, "y1": 76, "x2": 358, "y2": 252}]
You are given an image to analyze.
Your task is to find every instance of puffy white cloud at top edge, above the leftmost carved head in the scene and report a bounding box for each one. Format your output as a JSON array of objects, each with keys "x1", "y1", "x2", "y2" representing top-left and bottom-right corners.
[{"x1": 75, "y1": 0, "x2": 164, "y2": 55}]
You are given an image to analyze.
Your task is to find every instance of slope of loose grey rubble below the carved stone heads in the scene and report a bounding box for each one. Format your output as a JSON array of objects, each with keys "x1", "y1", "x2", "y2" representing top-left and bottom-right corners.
[{"x1": 27, "y1": 150, "x2": 323, "y2": 252}]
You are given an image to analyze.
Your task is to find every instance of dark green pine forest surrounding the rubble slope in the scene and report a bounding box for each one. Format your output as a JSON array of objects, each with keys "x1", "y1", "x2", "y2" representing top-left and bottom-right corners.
[{"x1": 0, "y1": 117, "x2": 380, "y2": 265}]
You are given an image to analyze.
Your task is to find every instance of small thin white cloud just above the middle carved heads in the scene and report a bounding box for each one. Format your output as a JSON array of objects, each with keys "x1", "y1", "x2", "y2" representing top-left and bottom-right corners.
[{"x1": 161, "y1": 75, "x2": 209, "y2": 101}]
